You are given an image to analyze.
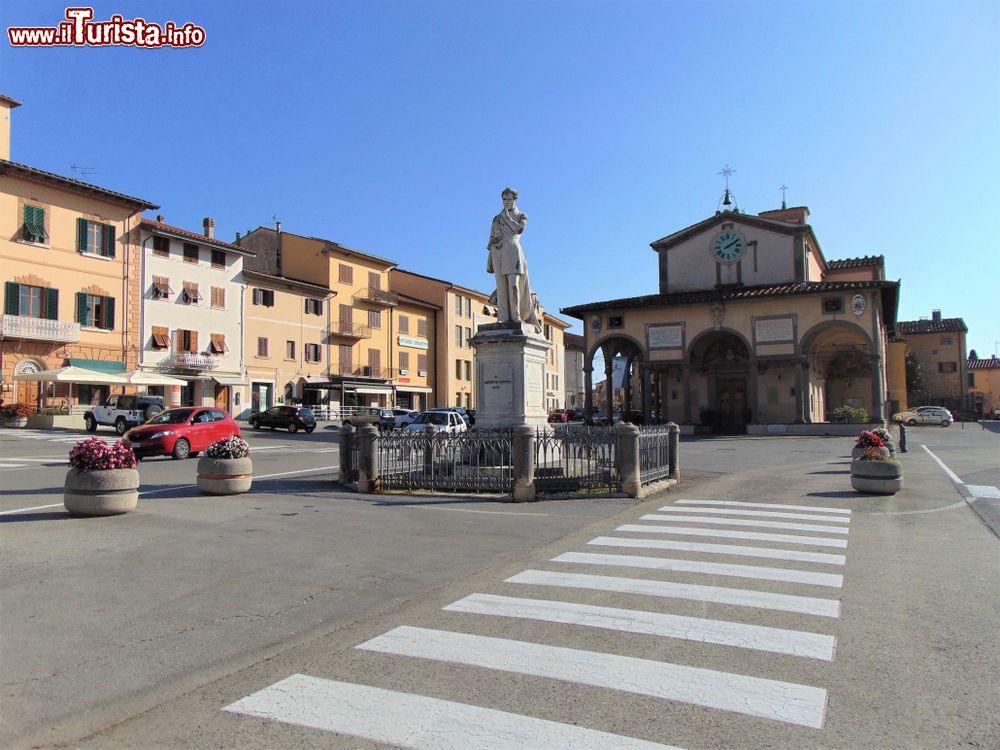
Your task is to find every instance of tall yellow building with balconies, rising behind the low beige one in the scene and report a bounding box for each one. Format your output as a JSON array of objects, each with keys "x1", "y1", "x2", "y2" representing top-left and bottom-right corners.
[{"x1": 236, "y1": 225, "x2": 398, "y2": 410}]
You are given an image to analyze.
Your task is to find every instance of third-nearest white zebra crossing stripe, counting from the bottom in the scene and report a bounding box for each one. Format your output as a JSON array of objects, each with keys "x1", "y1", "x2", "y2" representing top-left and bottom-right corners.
[{"x1": 443, "y1": 594, "x2": 836, "y2": 661}]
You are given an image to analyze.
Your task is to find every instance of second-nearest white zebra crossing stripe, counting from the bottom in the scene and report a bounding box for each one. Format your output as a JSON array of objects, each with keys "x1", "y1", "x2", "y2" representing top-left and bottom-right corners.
[{"x1": 358, "y1": 625, "x2": 826, "y2": 729}]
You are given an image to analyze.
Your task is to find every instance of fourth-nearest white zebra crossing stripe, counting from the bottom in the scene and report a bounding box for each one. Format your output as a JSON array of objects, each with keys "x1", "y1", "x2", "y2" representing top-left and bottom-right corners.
[{"x1": 506, "y1": 570, "x2": 840, "y2": 617}]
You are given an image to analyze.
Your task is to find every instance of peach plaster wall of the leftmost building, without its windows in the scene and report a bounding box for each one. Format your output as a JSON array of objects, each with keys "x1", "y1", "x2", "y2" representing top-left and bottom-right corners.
[{"x1": 0, "y1": 176, "x2": 138, "y2": 401}]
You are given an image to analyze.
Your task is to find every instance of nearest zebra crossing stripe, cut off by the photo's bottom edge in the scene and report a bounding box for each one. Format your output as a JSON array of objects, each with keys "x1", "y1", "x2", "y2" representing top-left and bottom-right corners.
[{"x1": 222, "y1": 674, "x2": 680, "y2": 750}]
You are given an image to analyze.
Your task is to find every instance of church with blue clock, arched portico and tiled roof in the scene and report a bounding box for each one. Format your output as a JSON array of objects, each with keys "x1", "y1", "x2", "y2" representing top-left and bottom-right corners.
[{"x1": 562, "y1": 207, "x2": 899, "y2": 434}]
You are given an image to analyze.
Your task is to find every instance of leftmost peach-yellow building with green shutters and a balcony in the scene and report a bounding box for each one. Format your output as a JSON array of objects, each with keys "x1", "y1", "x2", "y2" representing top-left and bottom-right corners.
[{"x1": 0, "y1": 95, "x2": 158, "y2": 412}]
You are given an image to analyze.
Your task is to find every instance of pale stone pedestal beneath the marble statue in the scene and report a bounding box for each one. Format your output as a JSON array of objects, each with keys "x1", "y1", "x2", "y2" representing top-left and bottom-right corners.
[{"x1": 471, "y1": 323, "x2": 552, "y2": 428}]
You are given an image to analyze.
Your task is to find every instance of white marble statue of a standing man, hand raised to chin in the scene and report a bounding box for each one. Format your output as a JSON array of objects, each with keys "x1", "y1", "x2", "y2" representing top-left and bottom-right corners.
[{"x1": 486, "y1": 188, "x2": 542, "y2": 333}]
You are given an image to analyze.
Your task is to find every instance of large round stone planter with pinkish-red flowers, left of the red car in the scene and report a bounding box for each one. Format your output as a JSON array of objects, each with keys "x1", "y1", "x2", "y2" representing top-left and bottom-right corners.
[{"x1": 63, "y1": 437, "x2": 139, "y2": 516}]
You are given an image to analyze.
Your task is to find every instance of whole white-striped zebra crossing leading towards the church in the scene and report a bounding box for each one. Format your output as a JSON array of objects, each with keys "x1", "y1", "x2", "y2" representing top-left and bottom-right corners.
[{"x1": 223, "y1": 499, "x2": 851, "y2": 750}]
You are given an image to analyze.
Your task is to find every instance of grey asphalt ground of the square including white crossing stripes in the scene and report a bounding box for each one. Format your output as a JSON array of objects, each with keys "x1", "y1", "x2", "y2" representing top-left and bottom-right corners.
[{"x1": 0, "y1": 425, "x2": 1000, "y2": 749}]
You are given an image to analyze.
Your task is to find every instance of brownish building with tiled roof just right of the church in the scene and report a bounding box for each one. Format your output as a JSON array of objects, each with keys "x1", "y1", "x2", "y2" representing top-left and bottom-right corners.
[{"x1": 896, "y1": 310, "x2": 969, "y2": 412}]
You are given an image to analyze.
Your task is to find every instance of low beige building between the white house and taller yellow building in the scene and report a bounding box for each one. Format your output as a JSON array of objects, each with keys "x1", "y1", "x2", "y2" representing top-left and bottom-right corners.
[{"x1": 239, "y1": 269, "x2": 336, "y2": 418}]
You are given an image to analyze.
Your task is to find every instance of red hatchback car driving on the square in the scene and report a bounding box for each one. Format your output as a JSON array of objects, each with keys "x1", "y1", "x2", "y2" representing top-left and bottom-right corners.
[{"x1": 124, "y1": 406, "x2": 243, "y2": 458}]
